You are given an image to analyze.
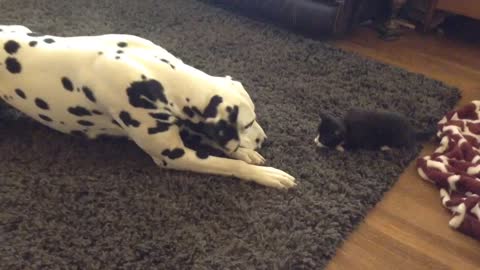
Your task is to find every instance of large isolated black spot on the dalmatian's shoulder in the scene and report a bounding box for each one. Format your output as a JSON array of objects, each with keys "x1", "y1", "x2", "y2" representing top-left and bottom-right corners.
[{"x1": 127, "y1": 80, "x2": 168, "y2": 109}]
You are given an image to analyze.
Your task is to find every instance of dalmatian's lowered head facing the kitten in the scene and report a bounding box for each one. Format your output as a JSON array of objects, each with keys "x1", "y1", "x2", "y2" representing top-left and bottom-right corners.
[{"x1": 199, "y1": 76, "x2": 267, "y2": 152}]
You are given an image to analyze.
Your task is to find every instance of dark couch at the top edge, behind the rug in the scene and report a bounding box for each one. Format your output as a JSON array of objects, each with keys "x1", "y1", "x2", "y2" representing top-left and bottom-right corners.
[{"x1": 202, "y1": 0, "x2": 389, "y2": 37}]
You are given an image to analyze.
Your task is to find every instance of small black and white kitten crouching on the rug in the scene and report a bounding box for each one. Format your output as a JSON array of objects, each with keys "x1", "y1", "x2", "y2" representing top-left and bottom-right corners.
[{"x1": 315, "y1": 109, "x2": 435, "y2": 151}]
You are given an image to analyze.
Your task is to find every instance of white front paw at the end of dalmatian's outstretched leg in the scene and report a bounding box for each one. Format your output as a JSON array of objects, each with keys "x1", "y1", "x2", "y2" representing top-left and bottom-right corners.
[{"x1": 251, "y1": 166, "x2": 297, "y2": 189}]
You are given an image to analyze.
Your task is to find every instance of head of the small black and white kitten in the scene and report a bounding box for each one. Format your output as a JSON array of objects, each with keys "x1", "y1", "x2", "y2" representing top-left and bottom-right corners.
[{"x1": 315, "y1": 114, "x2": 345, "y2": 148}]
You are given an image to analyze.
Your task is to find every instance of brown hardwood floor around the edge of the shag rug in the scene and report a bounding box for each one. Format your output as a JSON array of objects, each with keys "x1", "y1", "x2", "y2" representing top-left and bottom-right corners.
[{"x1": 327, "y1": 29, "x2": 480, "y2": 270}]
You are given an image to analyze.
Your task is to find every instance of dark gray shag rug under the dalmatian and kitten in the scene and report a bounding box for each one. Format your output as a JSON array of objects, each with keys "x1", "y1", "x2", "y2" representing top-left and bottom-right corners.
[{"x1": 0, "y1": 0, "x2": 459, "y2": 269}]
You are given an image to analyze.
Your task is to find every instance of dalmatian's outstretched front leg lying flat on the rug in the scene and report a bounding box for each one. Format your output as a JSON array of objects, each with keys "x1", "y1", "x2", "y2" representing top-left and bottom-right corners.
[{"x1": 120, "y1": 121, "x2": 296, "y2": 188}]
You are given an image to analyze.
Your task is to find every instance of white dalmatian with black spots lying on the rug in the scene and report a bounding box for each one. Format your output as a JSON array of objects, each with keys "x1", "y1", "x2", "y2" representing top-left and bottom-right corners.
[{"x1": 0, "y1": 25, "x2": 296, "y2": 188}]
